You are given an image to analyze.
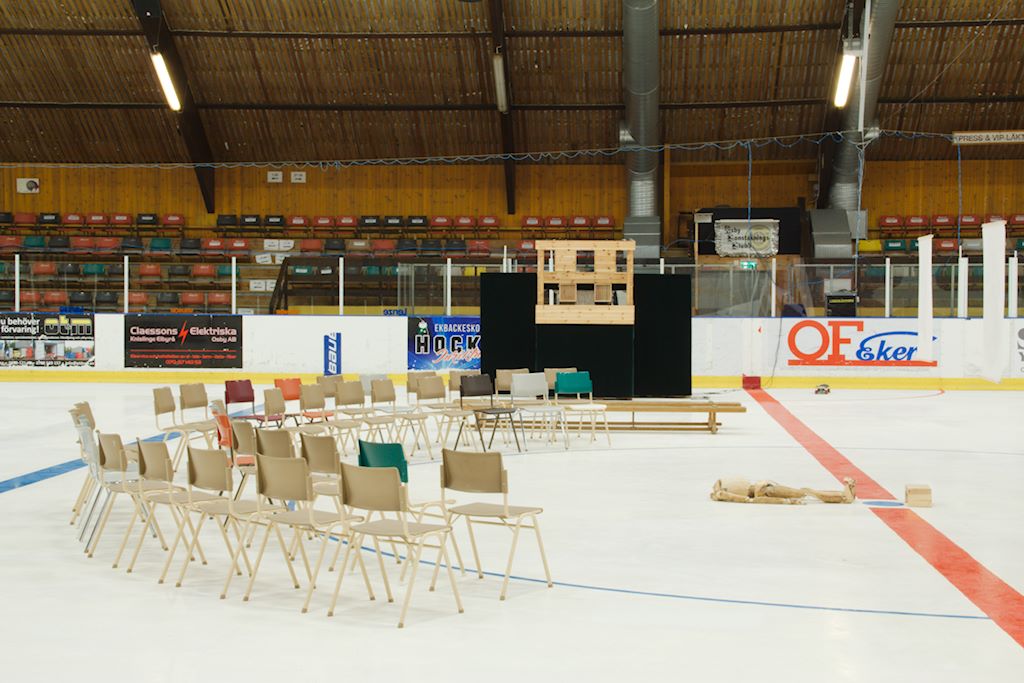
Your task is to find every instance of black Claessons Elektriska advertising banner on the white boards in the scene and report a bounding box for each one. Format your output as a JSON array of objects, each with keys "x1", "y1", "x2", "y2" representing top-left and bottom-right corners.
[{"x1": 125, "y1": 313, "x2": 242, "y2": 369}]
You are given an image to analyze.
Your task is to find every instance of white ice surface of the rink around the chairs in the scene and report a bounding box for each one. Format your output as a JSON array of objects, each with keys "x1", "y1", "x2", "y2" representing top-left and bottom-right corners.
[{"x1": 0, "y1": 383, "x2": 1024, "y2": 683}]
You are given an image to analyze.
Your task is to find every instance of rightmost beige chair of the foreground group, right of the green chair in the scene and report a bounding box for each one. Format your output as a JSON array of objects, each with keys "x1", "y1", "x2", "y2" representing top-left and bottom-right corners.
[{"x1": 441, "y1": 449, "x2": 554, "y2": 600}]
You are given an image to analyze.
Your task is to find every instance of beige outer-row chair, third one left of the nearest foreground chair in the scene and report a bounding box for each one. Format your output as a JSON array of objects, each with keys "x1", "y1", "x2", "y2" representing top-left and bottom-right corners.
[{"x1": 122, "y1": 439, "x2": 215, "y2": 583}]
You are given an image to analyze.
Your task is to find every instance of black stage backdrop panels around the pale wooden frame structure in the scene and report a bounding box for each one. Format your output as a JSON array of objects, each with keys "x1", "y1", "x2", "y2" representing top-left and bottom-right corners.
[{"x1": 480, "y1": 272, "x2": 691, "y2": 397}]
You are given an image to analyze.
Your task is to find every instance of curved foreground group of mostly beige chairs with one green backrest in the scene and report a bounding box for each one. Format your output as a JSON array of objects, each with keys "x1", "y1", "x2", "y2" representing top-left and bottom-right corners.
[{"x1": 72, "y1": 403, "x2": 553, "y2": 628}]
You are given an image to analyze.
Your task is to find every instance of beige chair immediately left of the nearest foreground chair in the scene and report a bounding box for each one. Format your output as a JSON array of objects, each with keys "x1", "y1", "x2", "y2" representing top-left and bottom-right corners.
[{"x1": 222, "y1": 455, "x2": 373, "y2": 612}]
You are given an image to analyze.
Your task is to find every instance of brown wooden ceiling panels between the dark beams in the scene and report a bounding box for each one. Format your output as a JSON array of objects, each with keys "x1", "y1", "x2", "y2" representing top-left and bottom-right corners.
[{"x1": 0, "y1": 0, "x2": 1024, "y2": 162}]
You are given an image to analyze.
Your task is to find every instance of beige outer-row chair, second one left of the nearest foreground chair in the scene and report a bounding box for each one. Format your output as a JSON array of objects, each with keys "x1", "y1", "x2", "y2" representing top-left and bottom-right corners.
[{"x1": 160, "y1": 446, "x2": 262, "y2": 597}]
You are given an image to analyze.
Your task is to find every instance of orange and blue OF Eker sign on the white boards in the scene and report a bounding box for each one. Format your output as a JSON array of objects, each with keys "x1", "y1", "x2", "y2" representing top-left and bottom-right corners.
[{"x1": 786, "y1": 319, "x2": 938, "y2": 368}]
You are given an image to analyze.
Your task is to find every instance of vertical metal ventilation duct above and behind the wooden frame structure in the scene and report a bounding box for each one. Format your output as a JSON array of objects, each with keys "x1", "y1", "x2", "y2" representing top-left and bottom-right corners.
[{"x1": 620, "y1": 0, "x2": 662, "y2": 258}]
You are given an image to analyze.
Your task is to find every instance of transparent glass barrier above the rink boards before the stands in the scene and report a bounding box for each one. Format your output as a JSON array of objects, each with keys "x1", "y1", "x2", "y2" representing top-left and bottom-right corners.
[{"x1": 0, "y1": 253, "x2": 1024, "y2": 317}]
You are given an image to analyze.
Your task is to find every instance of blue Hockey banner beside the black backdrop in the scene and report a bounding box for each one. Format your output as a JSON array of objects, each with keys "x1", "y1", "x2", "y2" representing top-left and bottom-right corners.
[{"x1": 409, "y1": 315, "x2": 480, "y2": 370}]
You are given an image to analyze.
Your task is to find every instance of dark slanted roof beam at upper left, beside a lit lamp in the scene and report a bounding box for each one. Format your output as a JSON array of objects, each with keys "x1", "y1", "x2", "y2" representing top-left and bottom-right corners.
[{"x1": 132, "y1": 0, "x2": 216, "y2": 213}]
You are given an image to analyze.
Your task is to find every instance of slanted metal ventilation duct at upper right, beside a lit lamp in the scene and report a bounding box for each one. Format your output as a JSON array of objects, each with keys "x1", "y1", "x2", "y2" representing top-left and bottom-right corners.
[{"x1": 828, "y1": 0, "x2": 900, "y2": 211}]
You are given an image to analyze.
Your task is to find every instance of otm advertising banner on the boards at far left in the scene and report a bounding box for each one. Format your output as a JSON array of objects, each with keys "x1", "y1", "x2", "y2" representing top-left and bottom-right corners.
[{"x1": 0, "y1": 313, "x2": 96, "y2": 367}]
